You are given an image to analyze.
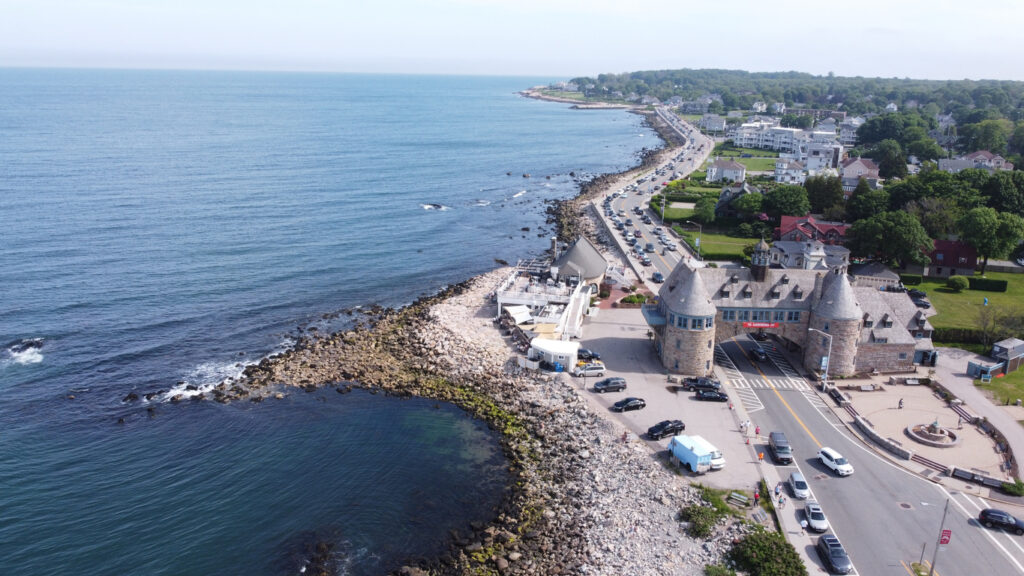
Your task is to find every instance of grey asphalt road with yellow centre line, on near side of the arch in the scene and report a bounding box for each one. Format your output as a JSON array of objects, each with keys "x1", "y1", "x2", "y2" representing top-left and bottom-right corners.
[{"x1": 721, "y1": 337, "x2": 1024, "y2": 576}]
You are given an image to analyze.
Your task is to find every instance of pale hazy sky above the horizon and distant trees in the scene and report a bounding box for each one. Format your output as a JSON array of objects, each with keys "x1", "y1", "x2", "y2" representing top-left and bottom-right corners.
[{"x1": 0, "y1": 0, "x2": 1024, "y2": 80}]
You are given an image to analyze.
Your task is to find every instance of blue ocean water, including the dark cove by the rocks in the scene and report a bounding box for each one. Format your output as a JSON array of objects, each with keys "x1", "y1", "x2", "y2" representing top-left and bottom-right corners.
[{"x1": 0, "y1": 70, "x2": 657, "y2": 574}]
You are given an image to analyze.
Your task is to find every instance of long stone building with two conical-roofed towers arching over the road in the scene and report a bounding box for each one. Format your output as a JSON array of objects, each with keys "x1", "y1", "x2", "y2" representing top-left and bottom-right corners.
[{"x1": 643, "y1": 240, "x2": 934, "y2": 376}]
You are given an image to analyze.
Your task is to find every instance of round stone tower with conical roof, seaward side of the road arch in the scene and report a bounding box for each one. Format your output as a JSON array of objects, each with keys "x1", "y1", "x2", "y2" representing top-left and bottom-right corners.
[{"x1": 658, "y1": 263, "x2": 718, "y2": 376}]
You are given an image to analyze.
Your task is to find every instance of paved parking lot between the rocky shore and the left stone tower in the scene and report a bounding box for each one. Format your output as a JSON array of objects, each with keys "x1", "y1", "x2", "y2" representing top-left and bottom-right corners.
[{"x1": 573, "y1": 308, "x2": 760, "y2": 491}]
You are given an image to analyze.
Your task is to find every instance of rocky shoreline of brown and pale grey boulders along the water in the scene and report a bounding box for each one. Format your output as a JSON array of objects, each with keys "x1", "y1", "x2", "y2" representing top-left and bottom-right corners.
[{"x1": 132, "y1": 106, "x2": 746, "y2": 576}]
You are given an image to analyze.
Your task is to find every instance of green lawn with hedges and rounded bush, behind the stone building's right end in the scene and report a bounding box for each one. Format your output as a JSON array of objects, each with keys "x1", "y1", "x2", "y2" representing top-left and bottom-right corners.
[{"x1": 909, "y1": 272, "x2": 1024, "y2": 328}]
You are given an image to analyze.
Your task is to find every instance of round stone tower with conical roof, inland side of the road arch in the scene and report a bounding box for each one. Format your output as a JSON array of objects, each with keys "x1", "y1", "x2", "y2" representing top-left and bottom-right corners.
[{"x1": 804, "y1": 270, "x2": 864, "y2": 376}]
